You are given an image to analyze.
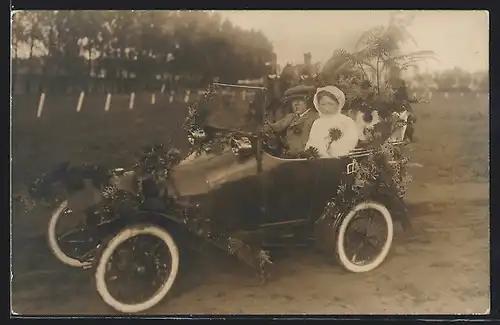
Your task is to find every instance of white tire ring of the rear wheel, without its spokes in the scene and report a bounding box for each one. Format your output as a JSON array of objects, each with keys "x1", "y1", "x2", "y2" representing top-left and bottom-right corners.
[{"x1": 335, "y1": 202, "x2": 394, "y2": 273}]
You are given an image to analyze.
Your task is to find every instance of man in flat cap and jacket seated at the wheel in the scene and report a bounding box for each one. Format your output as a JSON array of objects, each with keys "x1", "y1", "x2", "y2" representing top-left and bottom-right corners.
[{"x1": 264, "y1": 85, "x2": 318, "y2": 154}]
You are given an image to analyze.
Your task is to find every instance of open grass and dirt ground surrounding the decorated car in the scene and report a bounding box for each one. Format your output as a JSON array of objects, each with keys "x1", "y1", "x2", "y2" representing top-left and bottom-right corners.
[{"x1": 12, "y1": 91, "x2": 490, "y2": 314}]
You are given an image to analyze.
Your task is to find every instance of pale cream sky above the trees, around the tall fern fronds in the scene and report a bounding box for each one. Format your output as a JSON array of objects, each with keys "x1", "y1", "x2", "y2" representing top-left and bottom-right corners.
[{"x1": 218, "y1": 10, "x2": 489, "y2": 72}]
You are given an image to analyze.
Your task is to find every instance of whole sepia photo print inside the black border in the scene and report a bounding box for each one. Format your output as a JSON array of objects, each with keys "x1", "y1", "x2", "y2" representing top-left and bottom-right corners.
[{"x1": 10, "y1": 10, "x2": 490, "y2": 316}]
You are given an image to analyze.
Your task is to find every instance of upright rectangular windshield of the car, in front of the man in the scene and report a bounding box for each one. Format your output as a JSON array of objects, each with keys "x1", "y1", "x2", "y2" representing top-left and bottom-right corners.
[{"x1": 200, "y1": 83, "x2": 266, "y2": 133}]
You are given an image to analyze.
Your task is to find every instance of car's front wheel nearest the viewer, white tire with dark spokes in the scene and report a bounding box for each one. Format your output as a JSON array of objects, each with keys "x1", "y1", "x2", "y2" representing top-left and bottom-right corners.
[{"x1": 95, "y1": 224, "x2": 179, "y2": 313}]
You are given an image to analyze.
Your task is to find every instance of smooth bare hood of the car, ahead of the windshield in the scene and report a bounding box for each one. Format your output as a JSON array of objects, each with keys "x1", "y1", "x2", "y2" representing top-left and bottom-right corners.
[{"x1": 168, "y1": 149, "x2": 257, "y2": 197}]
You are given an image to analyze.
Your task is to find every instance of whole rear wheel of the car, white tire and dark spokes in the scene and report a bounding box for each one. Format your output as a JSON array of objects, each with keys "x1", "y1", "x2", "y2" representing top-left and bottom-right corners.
[{"x1": 335, "y1": 201, "x2": 394, "y2": 273}]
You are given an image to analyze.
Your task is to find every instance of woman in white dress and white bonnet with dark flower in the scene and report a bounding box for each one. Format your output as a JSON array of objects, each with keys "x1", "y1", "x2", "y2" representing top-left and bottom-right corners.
[{"x1": 306, "y1": 86, "x2": 359, "y2": 158}]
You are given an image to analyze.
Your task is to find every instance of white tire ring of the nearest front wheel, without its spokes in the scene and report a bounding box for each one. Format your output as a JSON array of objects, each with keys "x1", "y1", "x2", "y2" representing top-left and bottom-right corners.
[{"x1": 95, "y1": 225, "x2": 179, "y2": 314}]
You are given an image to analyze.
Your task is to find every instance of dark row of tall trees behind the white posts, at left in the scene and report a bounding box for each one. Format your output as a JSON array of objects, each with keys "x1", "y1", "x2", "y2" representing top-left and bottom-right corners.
[{"x1": 12, "y1": 10, "x2": 274, "y2": 92}]
